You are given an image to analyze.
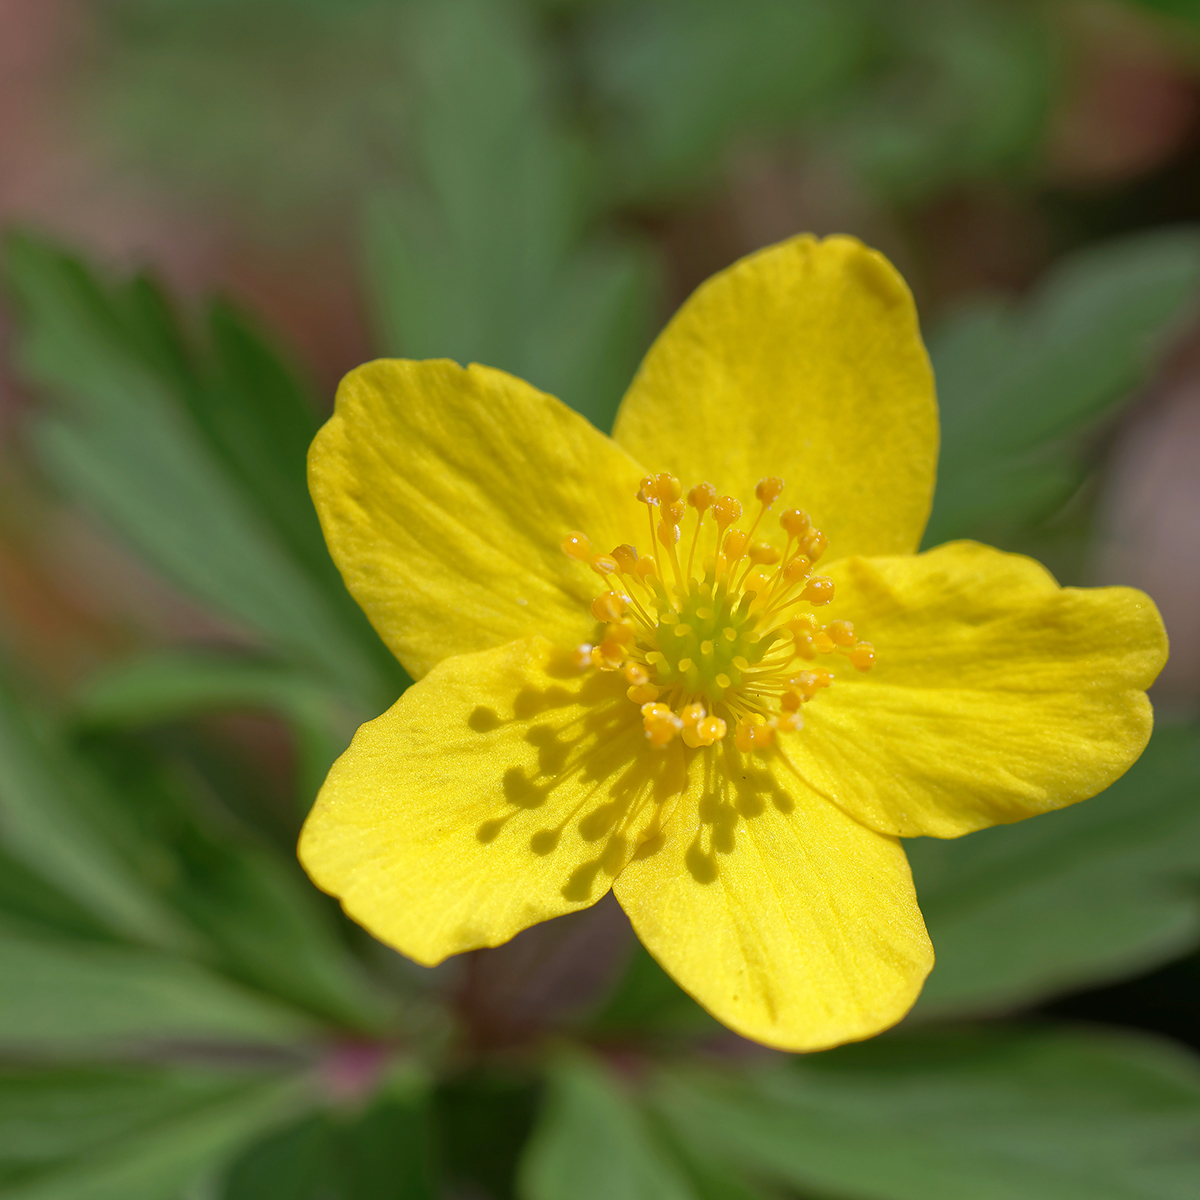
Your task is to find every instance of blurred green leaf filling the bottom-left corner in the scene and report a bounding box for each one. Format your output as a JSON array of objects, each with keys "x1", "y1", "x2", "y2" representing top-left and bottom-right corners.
[{"x1": 0, "y1": 1067, "x2": 302, "y2": 1200}]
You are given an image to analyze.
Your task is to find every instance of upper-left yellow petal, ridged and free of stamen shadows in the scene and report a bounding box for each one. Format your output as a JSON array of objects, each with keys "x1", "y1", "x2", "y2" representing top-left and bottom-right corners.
[{"x1": 308, "y1": 360, "x2": 644, "y2": 678}]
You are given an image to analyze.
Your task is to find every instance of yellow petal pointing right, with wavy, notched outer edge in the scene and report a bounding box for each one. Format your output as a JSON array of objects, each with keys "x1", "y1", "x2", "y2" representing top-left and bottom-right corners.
[{"x1": 775, "y1": 542, "x2": 1166, "y2": 838}]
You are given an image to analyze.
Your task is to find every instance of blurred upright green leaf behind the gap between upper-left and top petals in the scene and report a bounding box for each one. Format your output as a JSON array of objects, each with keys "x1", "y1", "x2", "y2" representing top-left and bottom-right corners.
[{"x1": 365, "y1": 0, "x2": 656, "y2": 428}]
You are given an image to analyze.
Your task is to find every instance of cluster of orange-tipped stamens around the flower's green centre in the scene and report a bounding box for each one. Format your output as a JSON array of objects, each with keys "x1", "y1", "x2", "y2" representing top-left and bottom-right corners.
[{"x1": 563, "y1": 474, "x2": 875, "y2": 751}]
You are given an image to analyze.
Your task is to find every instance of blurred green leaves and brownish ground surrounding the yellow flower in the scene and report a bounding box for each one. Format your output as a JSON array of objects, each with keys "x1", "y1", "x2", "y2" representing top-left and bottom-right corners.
[{"x1": 0, "y1": 0, "x2": 1200, "y2": 1200}]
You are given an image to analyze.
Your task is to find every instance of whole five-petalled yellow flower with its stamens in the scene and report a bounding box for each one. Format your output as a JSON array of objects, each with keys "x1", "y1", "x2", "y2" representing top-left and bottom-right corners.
[{"x1": 300, "y1": 236, "x2": 1166, "y2": 1050}]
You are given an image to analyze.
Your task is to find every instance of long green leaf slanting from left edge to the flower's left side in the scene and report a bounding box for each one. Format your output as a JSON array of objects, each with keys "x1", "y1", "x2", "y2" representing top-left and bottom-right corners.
[{"x1": 5, "y1": 231, "x2": 396, "y2": 710}]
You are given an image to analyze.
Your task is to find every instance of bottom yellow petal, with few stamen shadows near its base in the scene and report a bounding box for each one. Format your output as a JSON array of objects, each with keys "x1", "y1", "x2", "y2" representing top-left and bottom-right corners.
[{"x1": 613, "y1": 743, "x2": 934, "y2": 1050}]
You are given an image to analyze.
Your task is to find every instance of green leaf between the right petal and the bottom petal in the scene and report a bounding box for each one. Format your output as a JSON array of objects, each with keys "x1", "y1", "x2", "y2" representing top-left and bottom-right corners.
[{"x1": 905, "y1": 725, "x2": 1200, "y2": 1013}]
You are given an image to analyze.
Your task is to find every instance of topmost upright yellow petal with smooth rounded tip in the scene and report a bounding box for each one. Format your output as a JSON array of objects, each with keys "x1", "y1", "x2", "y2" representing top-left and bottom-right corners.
[{"x1": 613, "y1": 235, "x2": 937, "y2": 556}]
